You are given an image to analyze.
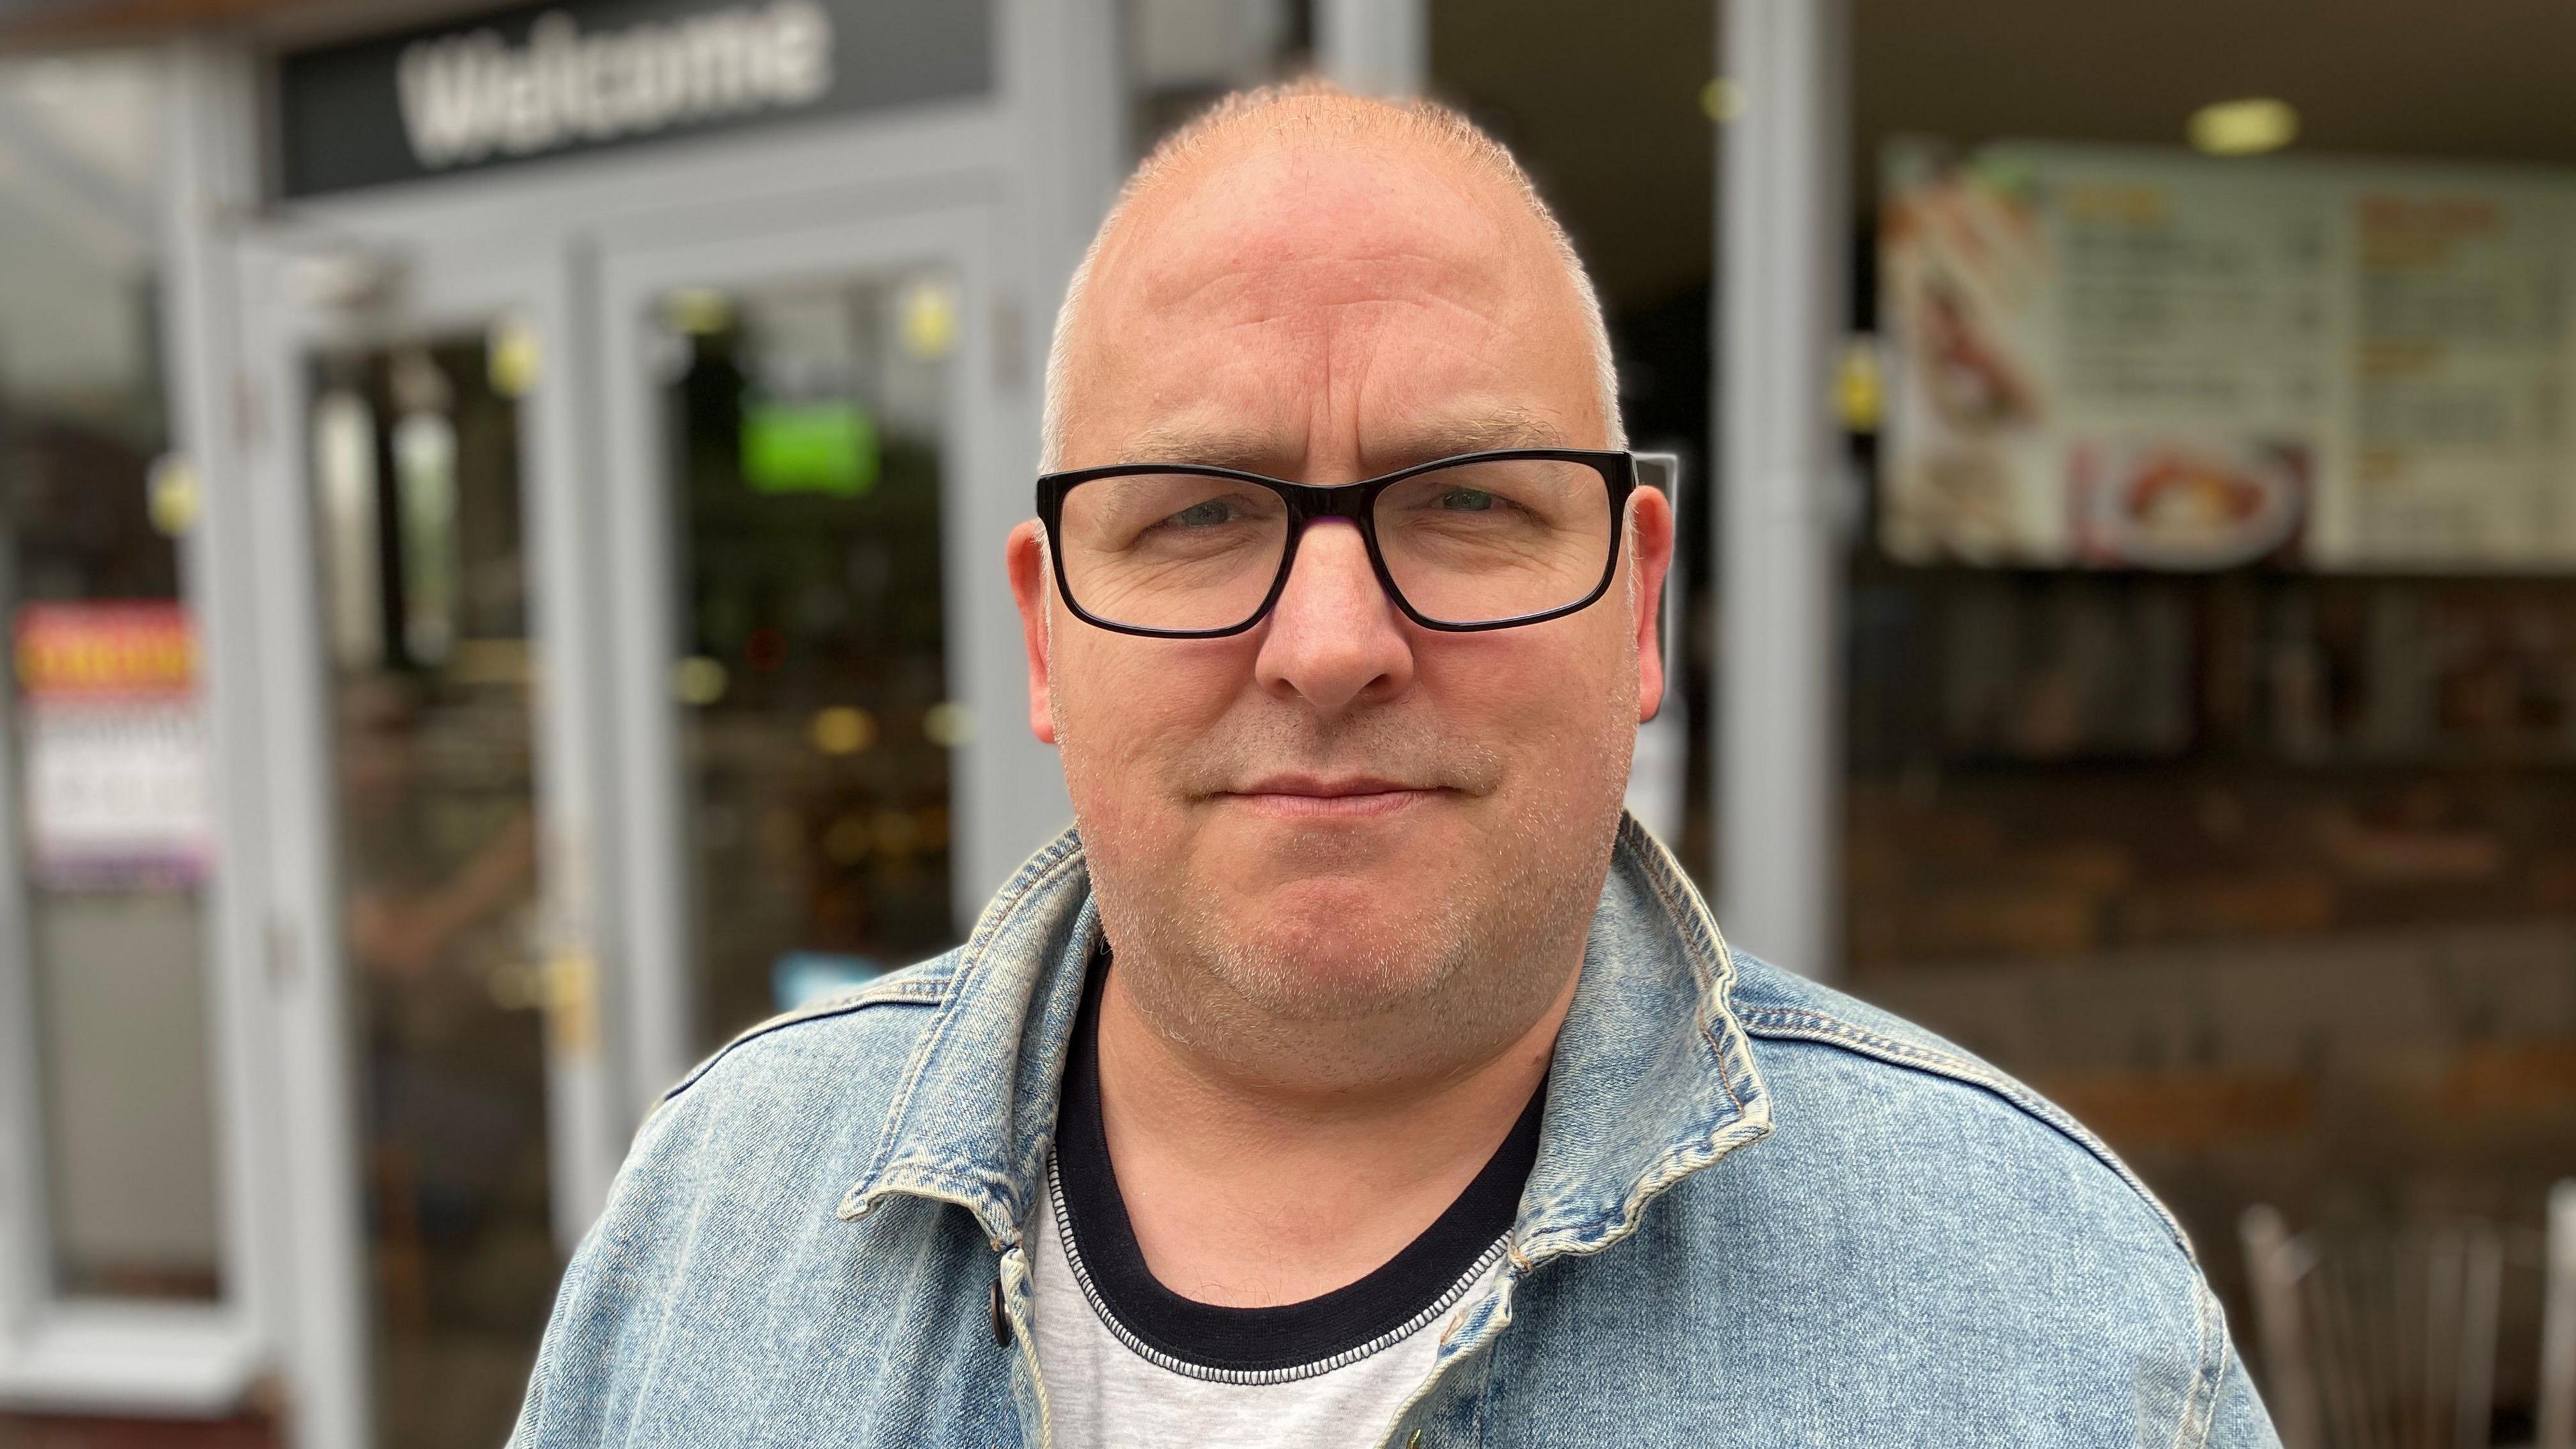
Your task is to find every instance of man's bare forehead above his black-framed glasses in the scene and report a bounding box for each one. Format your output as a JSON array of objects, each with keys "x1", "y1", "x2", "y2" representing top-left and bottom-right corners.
[{"x1": 1061, "y1": 140, "x2": 1589, "y2": 459}]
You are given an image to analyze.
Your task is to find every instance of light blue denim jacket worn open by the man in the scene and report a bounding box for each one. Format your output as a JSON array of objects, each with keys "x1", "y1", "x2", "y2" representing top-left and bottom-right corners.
[{"x1": 513, "y1": 822, "x2": 2277, "y2": 1449}]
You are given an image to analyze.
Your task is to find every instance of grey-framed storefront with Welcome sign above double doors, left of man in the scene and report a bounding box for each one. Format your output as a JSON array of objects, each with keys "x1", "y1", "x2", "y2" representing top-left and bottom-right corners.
[{"x1": 0, "y1": 0, "x2": 1123, "y2": 1446}]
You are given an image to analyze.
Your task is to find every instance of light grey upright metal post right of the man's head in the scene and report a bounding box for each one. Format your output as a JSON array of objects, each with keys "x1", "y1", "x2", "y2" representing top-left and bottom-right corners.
[{"x1": 1713, "y1": 0, "x2": 1849, "y2": 977}]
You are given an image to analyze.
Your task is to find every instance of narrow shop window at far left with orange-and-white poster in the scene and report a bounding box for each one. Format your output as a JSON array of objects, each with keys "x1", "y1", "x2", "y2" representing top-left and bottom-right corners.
[{"x1": 0, "y1": 54, "x2": 224, "y2": 1299}]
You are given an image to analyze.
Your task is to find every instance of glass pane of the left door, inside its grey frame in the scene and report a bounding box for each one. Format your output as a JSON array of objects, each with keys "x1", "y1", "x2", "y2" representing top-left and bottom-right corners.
[{"x1": 307, "y1": 333, "x2": 561, "y2": 1446}]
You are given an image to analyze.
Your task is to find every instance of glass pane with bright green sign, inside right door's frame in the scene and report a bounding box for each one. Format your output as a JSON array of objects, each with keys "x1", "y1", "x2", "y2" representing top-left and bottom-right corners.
[{"x1": 654, "y1": 263, "x2": 963, "y2": 1036}]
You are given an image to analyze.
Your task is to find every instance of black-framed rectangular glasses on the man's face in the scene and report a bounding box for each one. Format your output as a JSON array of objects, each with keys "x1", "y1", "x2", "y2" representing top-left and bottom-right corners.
[{"x1": 1038, "y1": 449, "x2": 1638, "y2": 639}]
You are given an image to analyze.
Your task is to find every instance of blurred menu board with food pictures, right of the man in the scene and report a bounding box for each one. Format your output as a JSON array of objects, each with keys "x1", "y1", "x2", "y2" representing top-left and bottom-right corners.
[{"x1": 1880, "y1": 142, "x2": 2576, "y2": 572}]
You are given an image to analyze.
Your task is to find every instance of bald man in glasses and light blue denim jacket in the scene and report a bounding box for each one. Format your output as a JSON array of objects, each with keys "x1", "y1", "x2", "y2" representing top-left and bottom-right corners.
[{"x1": 518, "y1": 88, "x2": 2272, "y2": 1449}]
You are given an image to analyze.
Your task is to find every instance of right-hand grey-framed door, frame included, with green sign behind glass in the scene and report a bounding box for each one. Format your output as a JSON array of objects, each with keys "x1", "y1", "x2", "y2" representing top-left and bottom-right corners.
[{"x1": 603, "y1": 197, "x2": 1069, "y2": 1093}]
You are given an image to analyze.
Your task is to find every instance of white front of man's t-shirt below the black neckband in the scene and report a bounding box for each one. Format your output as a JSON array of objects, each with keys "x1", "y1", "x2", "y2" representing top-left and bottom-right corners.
[{"x1": 1030, "y1": 1155, "x2": 1502, "y2": 1449}]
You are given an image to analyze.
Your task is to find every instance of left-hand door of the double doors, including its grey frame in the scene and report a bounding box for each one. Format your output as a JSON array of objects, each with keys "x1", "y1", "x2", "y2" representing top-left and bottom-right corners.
[{"x1": 255, "y1": 242, "x2": 634, "y2": 1449}]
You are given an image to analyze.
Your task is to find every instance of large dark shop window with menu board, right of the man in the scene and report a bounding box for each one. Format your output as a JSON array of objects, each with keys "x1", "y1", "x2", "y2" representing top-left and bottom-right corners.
[{"x1": 1844, "y1": 3, "x2": 2576, "y2": 1436}]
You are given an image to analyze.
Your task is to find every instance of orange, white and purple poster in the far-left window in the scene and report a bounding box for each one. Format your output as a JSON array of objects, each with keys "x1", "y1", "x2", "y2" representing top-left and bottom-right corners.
[{"x1": 15, "y1": 601, "x2": 211, "y2": 890}]
